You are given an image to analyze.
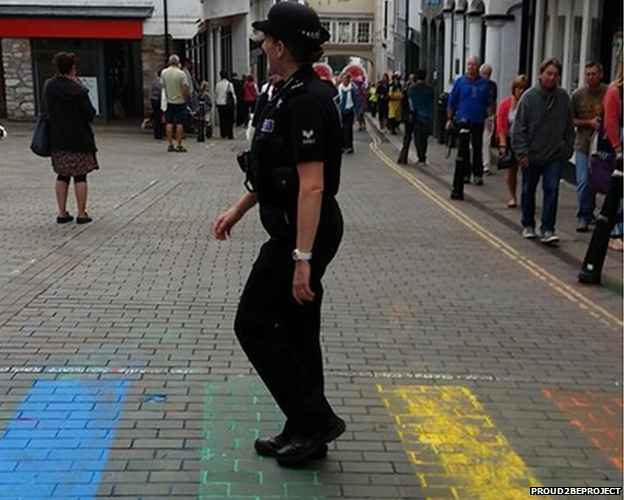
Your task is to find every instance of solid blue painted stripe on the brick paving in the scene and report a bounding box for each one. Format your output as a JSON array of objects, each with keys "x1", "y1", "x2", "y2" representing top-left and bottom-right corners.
[{"x1": 0, "y1": 380, "x2": 129, "y2": 500}]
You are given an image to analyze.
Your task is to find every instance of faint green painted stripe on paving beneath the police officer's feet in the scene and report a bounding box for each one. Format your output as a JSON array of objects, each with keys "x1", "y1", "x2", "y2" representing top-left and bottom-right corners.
[{"x1": 197, "y1": 377, "x2": 323, "y2": 500}]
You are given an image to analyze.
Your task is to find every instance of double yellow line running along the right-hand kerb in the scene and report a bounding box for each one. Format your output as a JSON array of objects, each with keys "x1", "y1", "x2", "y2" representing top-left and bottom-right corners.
[{"x1": 370, "y1": 135, "x2": 624, "y2": 328}]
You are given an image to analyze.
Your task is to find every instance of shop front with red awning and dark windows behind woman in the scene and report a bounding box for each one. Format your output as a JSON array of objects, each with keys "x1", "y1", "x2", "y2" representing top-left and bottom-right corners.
[{"x1": 0, "y1": 13, "x2": 144, "y2": 122}]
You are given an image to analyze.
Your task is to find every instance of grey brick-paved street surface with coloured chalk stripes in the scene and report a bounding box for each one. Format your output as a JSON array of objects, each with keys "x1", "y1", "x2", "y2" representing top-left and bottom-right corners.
[{"x1": 0, "y1": 122, "x2": 623, "y2": 500}]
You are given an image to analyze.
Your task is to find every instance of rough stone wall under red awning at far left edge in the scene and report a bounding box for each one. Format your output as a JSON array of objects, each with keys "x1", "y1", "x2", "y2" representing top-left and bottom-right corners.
[{"x1": 2, "y1": 38, "x2": 35, "y2": 121}]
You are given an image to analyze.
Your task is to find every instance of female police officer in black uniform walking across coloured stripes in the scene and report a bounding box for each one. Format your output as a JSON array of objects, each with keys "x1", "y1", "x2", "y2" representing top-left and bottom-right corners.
[{"x1": 213, "y1": 2, "x2": 345, "y2": 466}]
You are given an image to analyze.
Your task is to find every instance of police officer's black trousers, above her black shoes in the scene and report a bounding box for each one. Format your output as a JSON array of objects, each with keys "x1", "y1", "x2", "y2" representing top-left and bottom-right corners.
[{"x1": 234, "y1": 199, "x2": 343, "y2": 435}]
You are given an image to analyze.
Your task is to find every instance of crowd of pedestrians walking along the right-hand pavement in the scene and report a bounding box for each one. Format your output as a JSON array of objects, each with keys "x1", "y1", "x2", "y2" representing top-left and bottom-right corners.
[{"x1": 364, "y1": 56, "x2": 624, "y2": 251}]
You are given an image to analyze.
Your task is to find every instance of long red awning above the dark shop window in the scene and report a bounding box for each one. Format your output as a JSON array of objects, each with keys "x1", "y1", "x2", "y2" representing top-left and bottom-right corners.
[{"x1": 0, "y1": 18, "x2": 143, "y2": 40}]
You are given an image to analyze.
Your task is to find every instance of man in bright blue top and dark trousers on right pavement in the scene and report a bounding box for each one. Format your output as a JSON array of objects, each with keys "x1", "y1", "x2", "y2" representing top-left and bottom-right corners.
[{"x1": 446, "y1": 56, "x2": 493, "y2": 200}]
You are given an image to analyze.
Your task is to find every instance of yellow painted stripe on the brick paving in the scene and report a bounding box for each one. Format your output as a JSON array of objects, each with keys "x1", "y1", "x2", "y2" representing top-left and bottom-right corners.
[{"x1": 377, "y1": 385, "x2": 548, "y2": 500}]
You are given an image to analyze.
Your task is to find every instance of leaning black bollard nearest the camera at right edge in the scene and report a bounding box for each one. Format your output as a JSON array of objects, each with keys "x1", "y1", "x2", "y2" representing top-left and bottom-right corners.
[{"x1": 578, "y1": 155, "x2": 622, "y2": 285}]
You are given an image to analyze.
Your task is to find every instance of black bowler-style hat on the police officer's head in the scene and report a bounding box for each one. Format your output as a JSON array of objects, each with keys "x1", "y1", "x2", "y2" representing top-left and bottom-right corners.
[{"x1": 252, "y1": 1, "x2": 331, "y2": 47}]
